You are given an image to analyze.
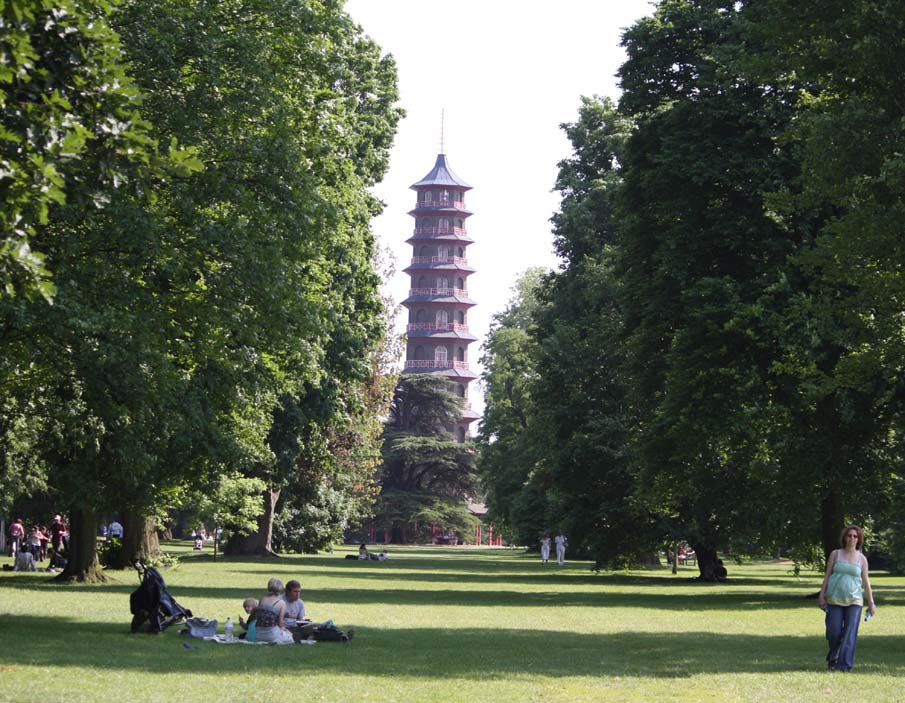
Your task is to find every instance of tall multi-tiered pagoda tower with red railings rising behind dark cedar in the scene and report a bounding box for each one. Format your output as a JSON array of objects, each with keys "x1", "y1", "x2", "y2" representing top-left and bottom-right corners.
[{"x1": 402, "y1": 153, "x2": 478, "y2": 442}]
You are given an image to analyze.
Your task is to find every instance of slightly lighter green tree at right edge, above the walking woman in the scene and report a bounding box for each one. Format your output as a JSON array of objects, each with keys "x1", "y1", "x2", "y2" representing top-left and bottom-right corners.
[{"x1": 742, "y1": 0, "x2": 905, "y2": 553}]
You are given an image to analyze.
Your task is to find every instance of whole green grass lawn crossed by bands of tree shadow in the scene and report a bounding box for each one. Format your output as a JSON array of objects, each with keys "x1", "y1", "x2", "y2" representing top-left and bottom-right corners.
[{"x1": 0, "y1": 546, "x2": 905, "y2": 703}]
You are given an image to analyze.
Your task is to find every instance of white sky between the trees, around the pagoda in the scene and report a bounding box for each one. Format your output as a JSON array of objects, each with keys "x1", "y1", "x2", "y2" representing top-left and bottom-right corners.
[{"x1": 346, "y1": 0, "x2": 652, "y2": 418}]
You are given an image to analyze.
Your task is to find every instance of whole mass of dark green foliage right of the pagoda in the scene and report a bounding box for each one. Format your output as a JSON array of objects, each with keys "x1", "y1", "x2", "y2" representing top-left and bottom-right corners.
[{"x1": 474, "y1": 0, "x2": 905, "y2": 578}]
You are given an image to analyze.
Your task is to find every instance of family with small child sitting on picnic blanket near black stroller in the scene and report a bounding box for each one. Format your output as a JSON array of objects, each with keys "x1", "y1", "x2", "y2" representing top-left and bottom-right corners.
[{"x1": 239, "y1": 578, "x2": 355, "y2": 644}]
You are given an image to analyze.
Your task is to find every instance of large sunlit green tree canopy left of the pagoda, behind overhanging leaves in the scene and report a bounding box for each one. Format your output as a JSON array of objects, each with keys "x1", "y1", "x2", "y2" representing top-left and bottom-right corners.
[{"x1": 0, "y1": 0, "x2": 400, "y2": 572}]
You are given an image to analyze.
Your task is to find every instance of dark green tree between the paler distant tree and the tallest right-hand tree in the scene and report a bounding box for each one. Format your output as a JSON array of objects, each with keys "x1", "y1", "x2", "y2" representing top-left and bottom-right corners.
[{"x1": 532, "y1": 99, "x2": 657, "y2": 565}]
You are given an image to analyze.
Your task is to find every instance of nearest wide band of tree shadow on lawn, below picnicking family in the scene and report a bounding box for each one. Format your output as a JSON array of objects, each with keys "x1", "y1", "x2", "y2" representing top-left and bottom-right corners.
[{"x1": 0, "y1": 616, "x2": 905, "y2": 679}]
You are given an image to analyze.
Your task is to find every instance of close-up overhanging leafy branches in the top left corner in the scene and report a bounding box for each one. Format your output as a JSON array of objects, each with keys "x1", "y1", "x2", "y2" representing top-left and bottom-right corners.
[{"x1": 0, "y1": 0, "x2": 164, "y2": 302}]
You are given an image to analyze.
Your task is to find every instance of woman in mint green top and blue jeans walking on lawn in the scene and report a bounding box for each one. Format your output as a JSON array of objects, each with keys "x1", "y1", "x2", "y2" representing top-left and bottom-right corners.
[{"x1": 817, "y1": 525, "x2": 877, "y2": 671}]
